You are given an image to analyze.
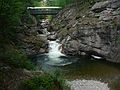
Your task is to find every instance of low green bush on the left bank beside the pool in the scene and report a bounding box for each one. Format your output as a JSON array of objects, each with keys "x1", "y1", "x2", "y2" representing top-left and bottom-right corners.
[{"x1": 0, "y1": 48, "x2": 34, "y2": 70}]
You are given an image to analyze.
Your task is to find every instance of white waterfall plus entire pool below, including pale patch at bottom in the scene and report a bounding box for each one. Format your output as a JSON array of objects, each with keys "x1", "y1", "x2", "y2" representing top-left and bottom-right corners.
[{"x1": 37, "y1": 41, "x2": 120, "y2": 90}]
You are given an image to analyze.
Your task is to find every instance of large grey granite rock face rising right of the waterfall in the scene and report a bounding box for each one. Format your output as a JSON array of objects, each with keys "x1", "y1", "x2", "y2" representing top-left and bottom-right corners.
[{"x1": 52, "y1": 0, "x2": 120, "y2": 63}]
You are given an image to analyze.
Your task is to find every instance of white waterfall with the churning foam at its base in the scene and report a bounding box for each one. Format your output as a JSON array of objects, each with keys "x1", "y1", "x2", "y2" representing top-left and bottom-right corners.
[{"x1": 47, "y1": 41, "x2": 72, "y2": 66}]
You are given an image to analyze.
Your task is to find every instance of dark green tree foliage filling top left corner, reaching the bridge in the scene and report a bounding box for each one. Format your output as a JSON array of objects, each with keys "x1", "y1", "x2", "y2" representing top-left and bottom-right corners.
[{"x1": 0, "y1": 0, "x2": 38, "y2": 39}]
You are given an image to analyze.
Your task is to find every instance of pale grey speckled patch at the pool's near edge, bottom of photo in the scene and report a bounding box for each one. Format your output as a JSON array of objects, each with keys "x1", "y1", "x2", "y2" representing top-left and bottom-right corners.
[{"x1": 67, "y1": 80, "x2": 110, "y2": 90}]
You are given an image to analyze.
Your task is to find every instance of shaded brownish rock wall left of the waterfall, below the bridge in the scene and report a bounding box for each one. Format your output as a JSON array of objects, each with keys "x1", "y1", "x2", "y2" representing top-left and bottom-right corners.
[{"x1": 17, "y1": 16, "x2": 48, "y2": 56}]
